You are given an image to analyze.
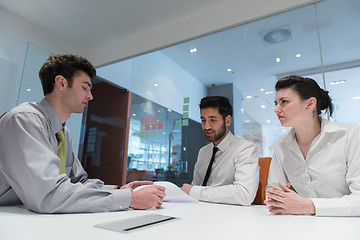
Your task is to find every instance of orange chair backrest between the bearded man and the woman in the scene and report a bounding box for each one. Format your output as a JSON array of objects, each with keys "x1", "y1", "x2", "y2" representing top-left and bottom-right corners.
[{"x1": 253, "y1": 157, "x2": 271, "y2": 205}]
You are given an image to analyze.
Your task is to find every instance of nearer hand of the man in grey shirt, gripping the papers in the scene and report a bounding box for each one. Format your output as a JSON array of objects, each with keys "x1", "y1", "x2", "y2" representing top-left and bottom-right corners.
[{"x1": 129, "y1": 185, "x2": 166, "y2": 209}]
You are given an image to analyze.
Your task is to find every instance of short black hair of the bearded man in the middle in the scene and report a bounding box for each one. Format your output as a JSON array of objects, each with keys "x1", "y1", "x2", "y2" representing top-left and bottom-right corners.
[{"x1": 200, "y1": 96, "x2": 233, "y2": 120}]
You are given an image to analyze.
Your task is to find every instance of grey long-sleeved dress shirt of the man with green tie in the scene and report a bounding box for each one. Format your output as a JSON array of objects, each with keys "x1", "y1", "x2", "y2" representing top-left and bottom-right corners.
[{"x1": 0, "y1": 99, "x2": 131, "y2": 213}]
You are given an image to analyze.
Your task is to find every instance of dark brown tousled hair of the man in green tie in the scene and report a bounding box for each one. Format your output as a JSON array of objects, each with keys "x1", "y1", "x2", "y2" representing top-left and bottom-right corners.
[{"x1": 39, "y1": 54, "x2": 96, "y2": 95}]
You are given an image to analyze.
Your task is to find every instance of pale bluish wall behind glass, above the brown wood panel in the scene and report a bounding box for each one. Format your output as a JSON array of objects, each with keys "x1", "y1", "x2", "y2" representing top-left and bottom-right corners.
[{"x1": 97, "y1": 52, "x2": 206, "y2": 122}]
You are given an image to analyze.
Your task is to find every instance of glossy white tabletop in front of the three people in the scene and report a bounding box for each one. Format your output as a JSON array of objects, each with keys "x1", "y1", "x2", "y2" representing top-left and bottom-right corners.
[{"x1": 0, "y1": 203, "x2": 360, "y2": 240}]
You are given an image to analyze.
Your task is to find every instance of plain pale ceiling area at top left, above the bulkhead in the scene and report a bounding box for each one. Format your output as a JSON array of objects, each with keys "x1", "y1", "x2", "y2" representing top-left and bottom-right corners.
[{"x1": 0, "y1": 0, "x2": 219, "y2": 50}]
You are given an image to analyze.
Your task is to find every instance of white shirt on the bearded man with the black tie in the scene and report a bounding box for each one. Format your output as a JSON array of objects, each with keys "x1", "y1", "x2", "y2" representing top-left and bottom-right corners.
[{"x1": 190, "y1": 131, "x2": 259, "y2": 205}]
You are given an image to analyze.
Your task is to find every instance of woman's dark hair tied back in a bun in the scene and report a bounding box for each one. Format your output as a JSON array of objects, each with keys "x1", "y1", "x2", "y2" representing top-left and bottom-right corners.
[{"x1": 275, "y1": 75, "x2": 334, "y2": 116}]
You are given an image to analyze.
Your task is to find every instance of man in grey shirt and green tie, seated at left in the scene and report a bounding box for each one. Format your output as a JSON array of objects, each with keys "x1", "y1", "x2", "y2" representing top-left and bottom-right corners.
[{"x1": 0, "y1": 54, "x2": 165, "y2": 213}]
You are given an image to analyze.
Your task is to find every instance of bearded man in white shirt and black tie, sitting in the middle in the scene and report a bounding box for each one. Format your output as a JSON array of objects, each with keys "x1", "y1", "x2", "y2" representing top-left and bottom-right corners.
[{"x1": 181, "y1": 96, "x2": 259, "y2": 205}]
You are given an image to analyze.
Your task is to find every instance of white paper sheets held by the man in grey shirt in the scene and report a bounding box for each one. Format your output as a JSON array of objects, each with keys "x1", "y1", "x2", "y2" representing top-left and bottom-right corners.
[{"x1": 134, "y1": 181, "x2": 198, "y2": 203}]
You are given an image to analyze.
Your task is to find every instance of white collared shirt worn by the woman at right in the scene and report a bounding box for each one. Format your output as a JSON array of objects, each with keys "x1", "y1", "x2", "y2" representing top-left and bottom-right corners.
[{"x1": 267, "y1": 118, "x2": 360, "y2": 216}]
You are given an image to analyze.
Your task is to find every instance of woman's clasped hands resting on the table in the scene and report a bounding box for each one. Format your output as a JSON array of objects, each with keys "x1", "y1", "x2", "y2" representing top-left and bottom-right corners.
[{"x1": 264, "y1": 182, "x2": 315, "y2": 214}]
